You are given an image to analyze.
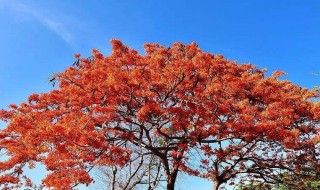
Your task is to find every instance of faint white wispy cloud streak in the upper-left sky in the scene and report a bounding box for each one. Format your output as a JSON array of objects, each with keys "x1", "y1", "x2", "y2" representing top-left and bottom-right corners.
[{"x1": 0, "y1": 0, "x2": 74, "y2": 44}]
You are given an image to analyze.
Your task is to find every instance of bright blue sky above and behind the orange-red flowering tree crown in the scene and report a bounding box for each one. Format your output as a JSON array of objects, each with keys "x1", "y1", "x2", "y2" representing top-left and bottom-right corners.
[{"x1": 0, "y1": 0, "x2": 320, "y2": 190}]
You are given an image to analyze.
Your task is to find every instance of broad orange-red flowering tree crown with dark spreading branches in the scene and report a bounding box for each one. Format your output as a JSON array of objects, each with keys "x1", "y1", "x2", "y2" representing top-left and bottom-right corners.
[{"x1": 0, "y1": 40, "x2": 320, "y2": 189}]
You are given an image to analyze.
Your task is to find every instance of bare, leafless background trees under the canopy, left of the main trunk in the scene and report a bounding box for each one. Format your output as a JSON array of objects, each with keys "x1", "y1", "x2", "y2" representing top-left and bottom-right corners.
[{"x1": 95, "y1": 142, "x2": 165, "y2": 190}]
